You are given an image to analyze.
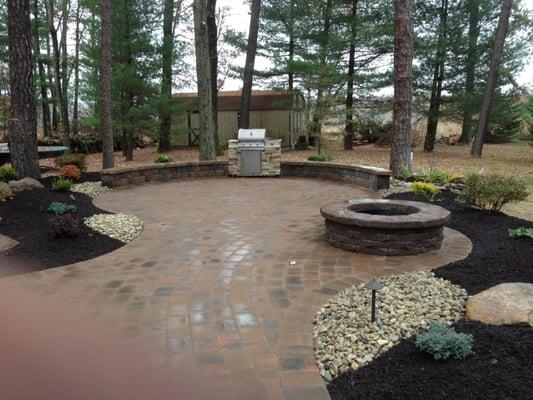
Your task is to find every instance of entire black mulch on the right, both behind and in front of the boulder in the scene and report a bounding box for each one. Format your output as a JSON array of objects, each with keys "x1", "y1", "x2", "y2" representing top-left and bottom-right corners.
[{"x1": 328, "y1": 193, "x2": 533, "y2": 400}]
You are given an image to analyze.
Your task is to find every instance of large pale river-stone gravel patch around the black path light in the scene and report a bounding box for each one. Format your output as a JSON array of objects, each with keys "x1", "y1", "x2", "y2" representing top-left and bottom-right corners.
[{"x1": 313, "y1": 272, "x2": 467, "y2": 382}]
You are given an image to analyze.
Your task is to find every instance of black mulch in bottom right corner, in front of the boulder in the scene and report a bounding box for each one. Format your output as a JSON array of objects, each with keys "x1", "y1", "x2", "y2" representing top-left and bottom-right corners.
[{"x1": 328, "y1": 321, "x2": 533, "y2": 400}]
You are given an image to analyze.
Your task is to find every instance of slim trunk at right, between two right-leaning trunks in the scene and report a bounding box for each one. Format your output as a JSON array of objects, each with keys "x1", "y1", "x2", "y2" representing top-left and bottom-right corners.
[{"x1": 459, "y1": 0, "x2": 480, "y2": 144}]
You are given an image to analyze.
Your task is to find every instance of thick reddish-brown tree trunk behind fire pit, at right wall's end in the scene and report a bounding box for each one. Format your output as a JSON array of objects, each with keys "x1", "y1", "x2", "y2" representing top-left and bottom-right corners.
[{"x1": 390, "y1": 0, "x2": 414, "y2": 177}]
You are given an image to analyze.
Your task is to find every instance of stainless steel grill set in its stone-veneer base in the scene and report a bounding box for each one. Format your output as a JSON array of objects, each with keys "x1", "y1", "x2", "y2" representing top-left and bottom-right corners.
[{"x1": 228, "y1": 129, "x2": 281, "y2": 176}]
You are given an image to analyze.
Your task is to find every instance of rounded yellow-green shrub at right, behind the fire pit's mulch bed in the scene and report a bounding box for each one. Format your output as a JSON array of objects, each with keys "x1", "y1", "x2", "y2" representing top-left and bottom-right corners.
[{"x1": 459, "y1": 173, "x2": 529, "y2": 212}]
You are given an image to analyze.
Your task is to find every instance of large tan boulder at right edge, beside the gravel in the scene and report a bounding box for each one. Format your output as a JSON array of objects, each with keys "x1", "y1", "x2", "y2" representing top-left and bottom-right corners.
[{"x1": 466, "y1": 282, "x2": 533, "y2": 325}]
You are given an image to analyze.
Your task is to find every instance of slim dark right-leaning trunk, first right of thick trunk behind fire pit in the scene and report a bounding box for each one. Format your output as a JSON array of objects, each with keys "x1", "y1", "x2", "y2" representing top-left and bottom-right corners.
[{"x1": 424, "y1": 0, "x2": 448, "y2": 151}]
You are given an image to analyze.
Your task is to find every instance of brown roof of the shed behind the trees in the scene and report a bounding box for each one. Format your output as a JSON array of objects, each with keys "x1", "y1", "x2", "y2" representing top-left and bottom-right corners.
[{"x1": 172, "y1": 90, "x2": 294, "y2": 112}]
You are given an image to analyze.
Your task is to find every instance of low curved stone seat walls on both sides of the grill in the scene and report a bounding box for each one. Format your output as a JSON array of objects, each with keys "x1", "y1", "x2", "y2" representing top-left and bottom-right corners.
[{"x1": 100, "y1": 161, "x2": 390, "y2": 190}]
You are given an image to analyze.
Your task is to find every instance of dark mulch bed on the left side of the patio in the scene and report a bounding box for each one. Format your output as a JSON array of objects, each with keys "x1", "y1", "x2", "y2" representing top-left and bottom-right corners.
[{"x1": 0, "y1": 174, "x2": 123, "y2": 276}]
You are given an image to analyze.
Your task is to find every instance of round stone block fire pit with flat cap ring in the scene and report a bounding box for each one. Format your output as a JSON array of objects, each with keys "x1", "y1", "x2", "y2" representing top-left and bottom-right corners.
[{"x1": 320, "y1": 199, "x2": 450, "y2": 256}]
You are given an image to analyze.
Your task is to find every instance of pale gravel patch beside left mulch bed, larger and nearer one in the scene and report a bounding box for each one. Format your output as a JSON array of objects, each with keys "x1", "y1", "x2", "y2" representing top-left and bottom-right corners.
[{"x1": 83, "y1": 214, "x2": 144, "y2": 243}]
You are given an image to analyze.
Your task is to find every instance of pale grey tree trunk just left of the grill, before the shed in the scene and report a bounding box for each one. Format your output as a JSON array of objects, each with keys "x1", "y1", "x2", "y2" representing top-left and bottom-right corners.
[{"x1": 193, "y1": 0, "x2": 216, "y2": 160}]
